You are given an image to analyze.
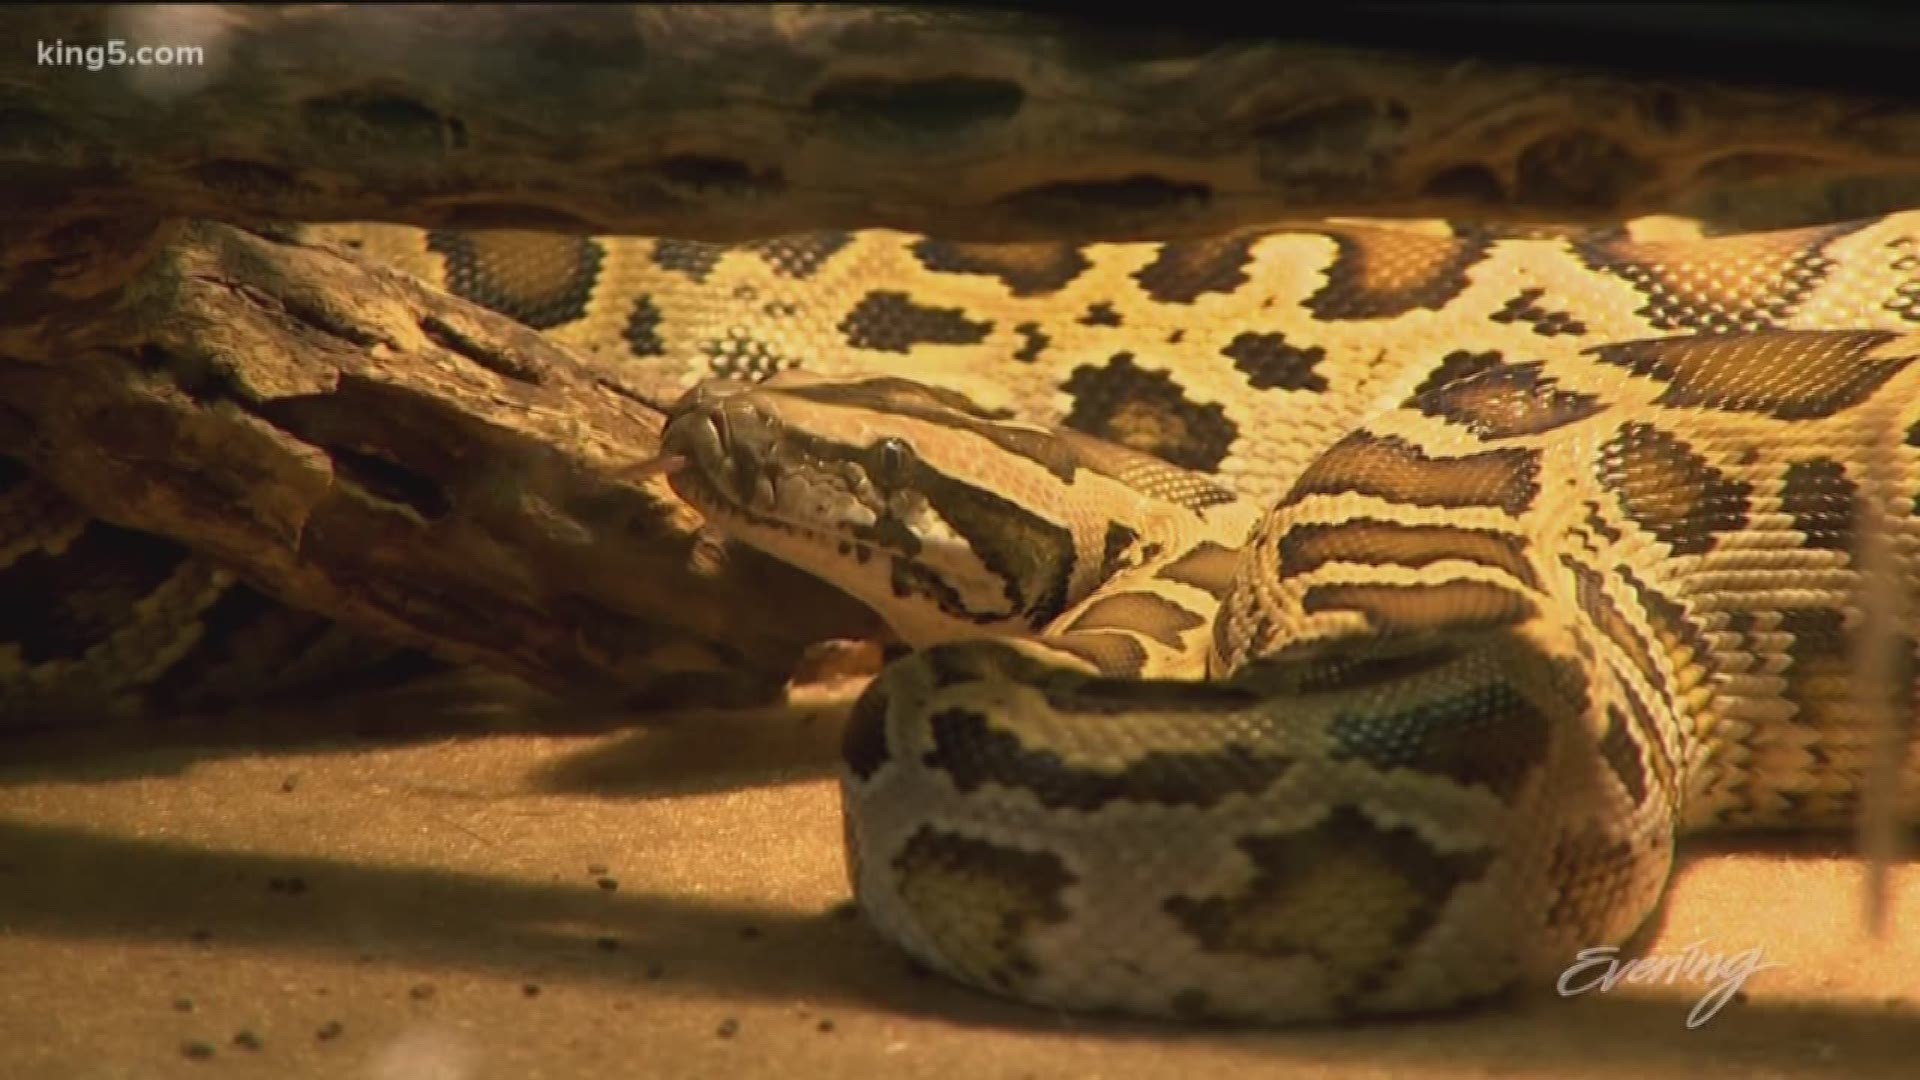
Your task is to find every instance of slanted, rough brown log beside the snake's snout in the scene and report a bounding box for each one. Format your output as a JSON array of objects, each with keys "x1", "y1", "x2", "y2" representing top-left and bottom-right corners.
[{"x1": 0, "y1": 223, "x2": 877, "y2": 700}]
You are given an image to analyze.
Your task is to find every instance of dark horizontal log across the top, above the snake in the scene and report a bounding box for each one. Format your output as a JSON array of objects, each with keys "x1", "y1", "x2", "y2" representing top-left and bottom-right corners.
[{"x1": 11, "y1": 4, "x2": 1920, "y2": 240}]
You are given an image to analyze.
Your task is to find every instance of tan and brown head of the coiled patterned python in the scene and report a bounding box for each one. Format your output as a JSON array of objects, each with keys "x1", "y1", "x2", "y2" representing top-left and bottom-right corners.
[{"x1": 660, "y1": 377, "x2": 1139, "y2": 646}]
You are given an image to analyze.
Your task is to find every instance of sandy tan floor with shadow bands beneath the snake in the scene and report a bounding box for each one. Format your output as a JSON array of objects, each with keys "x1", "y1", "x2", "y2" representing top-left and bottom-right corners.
[{"x1": 0, "y1": 676, "x2": 1920, "y2": 1080}]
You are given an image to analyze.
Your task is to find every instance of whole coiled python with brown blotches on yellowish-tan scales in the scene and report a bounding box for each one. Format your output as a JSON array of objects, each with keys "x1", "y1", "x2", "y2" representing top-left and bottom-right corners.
[{"x1": 0, "y1": 213, "x2": 1920, "y2": 1022}]
